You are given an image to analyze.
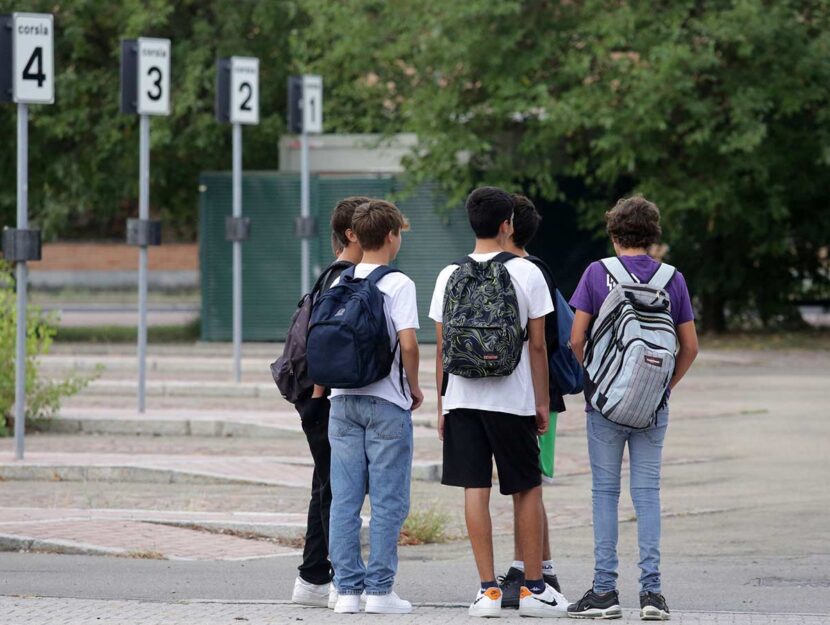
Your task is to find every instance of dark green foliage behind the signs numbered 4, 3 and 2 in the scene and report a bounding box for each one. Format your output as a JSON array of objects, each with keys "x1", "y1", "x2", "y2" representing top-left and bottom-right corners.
[{"x1": 0, "y1": 0, "x2": 306, "y2": 239}]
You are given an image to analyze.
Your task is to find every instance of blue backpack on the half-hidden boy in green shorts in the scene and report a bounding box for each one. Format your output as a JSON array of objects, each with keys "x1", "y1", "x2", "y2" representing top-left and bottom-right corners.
[{"x1": 525, "y1": 256, "x2": 583, "y2": 395}]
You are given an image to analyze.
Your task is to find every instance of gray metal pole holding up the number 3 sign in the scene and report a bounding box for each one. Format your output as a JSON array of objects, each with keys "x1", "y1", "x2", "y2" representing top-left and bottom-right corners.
[{"x1": 138, "y1": 115, "x2": 150, "y2": 412}]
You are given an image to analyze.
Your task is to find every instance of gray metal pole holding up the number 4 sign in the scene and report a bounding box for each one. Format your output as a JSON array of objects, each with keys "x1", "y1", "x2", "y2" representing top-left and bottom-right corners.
[{"x1": 14, "y1": 102, "x2": 29, "y2": 460}]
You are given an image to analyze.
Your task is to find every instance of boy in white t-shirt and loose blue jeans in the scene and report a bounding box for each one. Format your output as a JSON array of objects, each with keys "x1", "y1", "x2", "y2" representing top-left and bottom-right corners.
[{"x1": 329, "y1": 200, "x2": 424, "y2": 614}]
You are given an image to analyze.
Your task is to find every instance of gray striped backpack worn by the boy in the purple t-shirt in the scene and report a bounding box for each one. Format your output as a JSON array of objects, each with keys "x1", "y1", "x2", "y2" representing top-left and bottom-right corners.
[{"x1": 584, "y1": 257, "x2": 677, "y2": 428}]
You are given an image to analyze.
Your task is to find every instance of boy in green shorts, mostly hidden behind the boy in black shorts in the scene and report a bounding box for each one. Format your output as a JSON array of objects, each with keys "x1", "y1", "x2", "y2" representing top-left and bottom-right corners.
[{"x1": 499, "y1": 194, "x2": 565, "y2": 608}]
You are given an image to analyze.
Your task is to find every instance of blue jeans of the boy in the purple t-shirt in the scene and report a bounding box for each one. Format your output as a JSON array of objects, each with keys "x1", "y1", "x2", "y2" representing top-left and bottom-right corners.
[{"x1": 587, "y1": 409, "x2": 669, "y2": 593}]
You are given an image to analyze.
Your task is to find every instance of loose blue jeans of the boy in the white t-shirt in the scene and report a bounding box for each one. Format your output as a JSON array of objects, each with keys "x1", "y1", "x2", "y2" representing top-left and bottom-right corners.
[{"x1": 329, "y1": 395, "x2": 412, "y2": 595}]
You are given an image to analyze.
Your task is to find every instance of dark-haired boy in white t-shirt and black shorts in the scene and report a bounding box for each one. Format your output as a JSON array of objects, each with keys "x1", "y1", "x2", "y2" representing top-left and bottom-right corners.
[{"x1": 429, "y1": 187, "x2": 567, "y2": 616}]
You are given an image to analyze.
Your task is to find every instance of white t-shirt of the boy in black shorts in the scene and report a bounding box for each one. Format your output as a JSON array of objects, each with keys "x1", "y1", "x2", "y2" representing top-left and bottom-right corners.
[{"x1": 429, "y1": 252, "x2": 553, "y2": 416}]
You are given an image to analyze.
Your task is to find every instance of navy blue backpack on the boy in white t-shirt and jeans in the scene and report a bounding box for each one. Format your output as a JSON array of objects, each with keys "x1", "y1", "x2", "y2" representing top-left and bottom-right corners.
[{"x1": 306, "y1": 266, "x2": 403, "y2": 388}]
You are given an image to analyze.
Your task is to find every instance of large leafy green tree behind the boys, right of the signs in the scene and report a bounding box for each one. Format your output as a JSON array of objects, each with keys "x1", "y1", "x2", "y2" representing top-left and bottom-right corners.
[{"x1": 295, "y1": 0, "x2": 830, "y2": 331}]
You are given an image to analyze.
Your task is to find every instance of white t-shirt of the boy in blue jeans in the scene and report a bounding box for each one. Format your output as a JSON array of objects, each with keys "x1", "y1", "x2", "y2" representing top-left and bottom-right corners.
[{"x1": 331, "y1": 263, "x2": 420, "y2": 410}]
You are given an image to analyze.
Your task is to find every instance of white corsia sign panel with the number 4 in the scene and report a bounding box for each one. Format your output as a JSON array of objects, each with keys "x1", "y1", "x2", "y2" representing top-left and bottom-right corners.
[{"x1": 12, "y1": 13, "x2": 55, "y2": 104}]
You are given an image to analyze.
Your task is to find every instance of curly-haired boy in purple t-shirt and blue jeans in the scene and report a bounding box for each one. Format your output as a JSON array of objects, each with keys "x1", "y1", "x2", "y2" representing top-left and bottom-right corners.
[{"x1": 568, "y1": 197, "x2": 698, "y2": 620}]
